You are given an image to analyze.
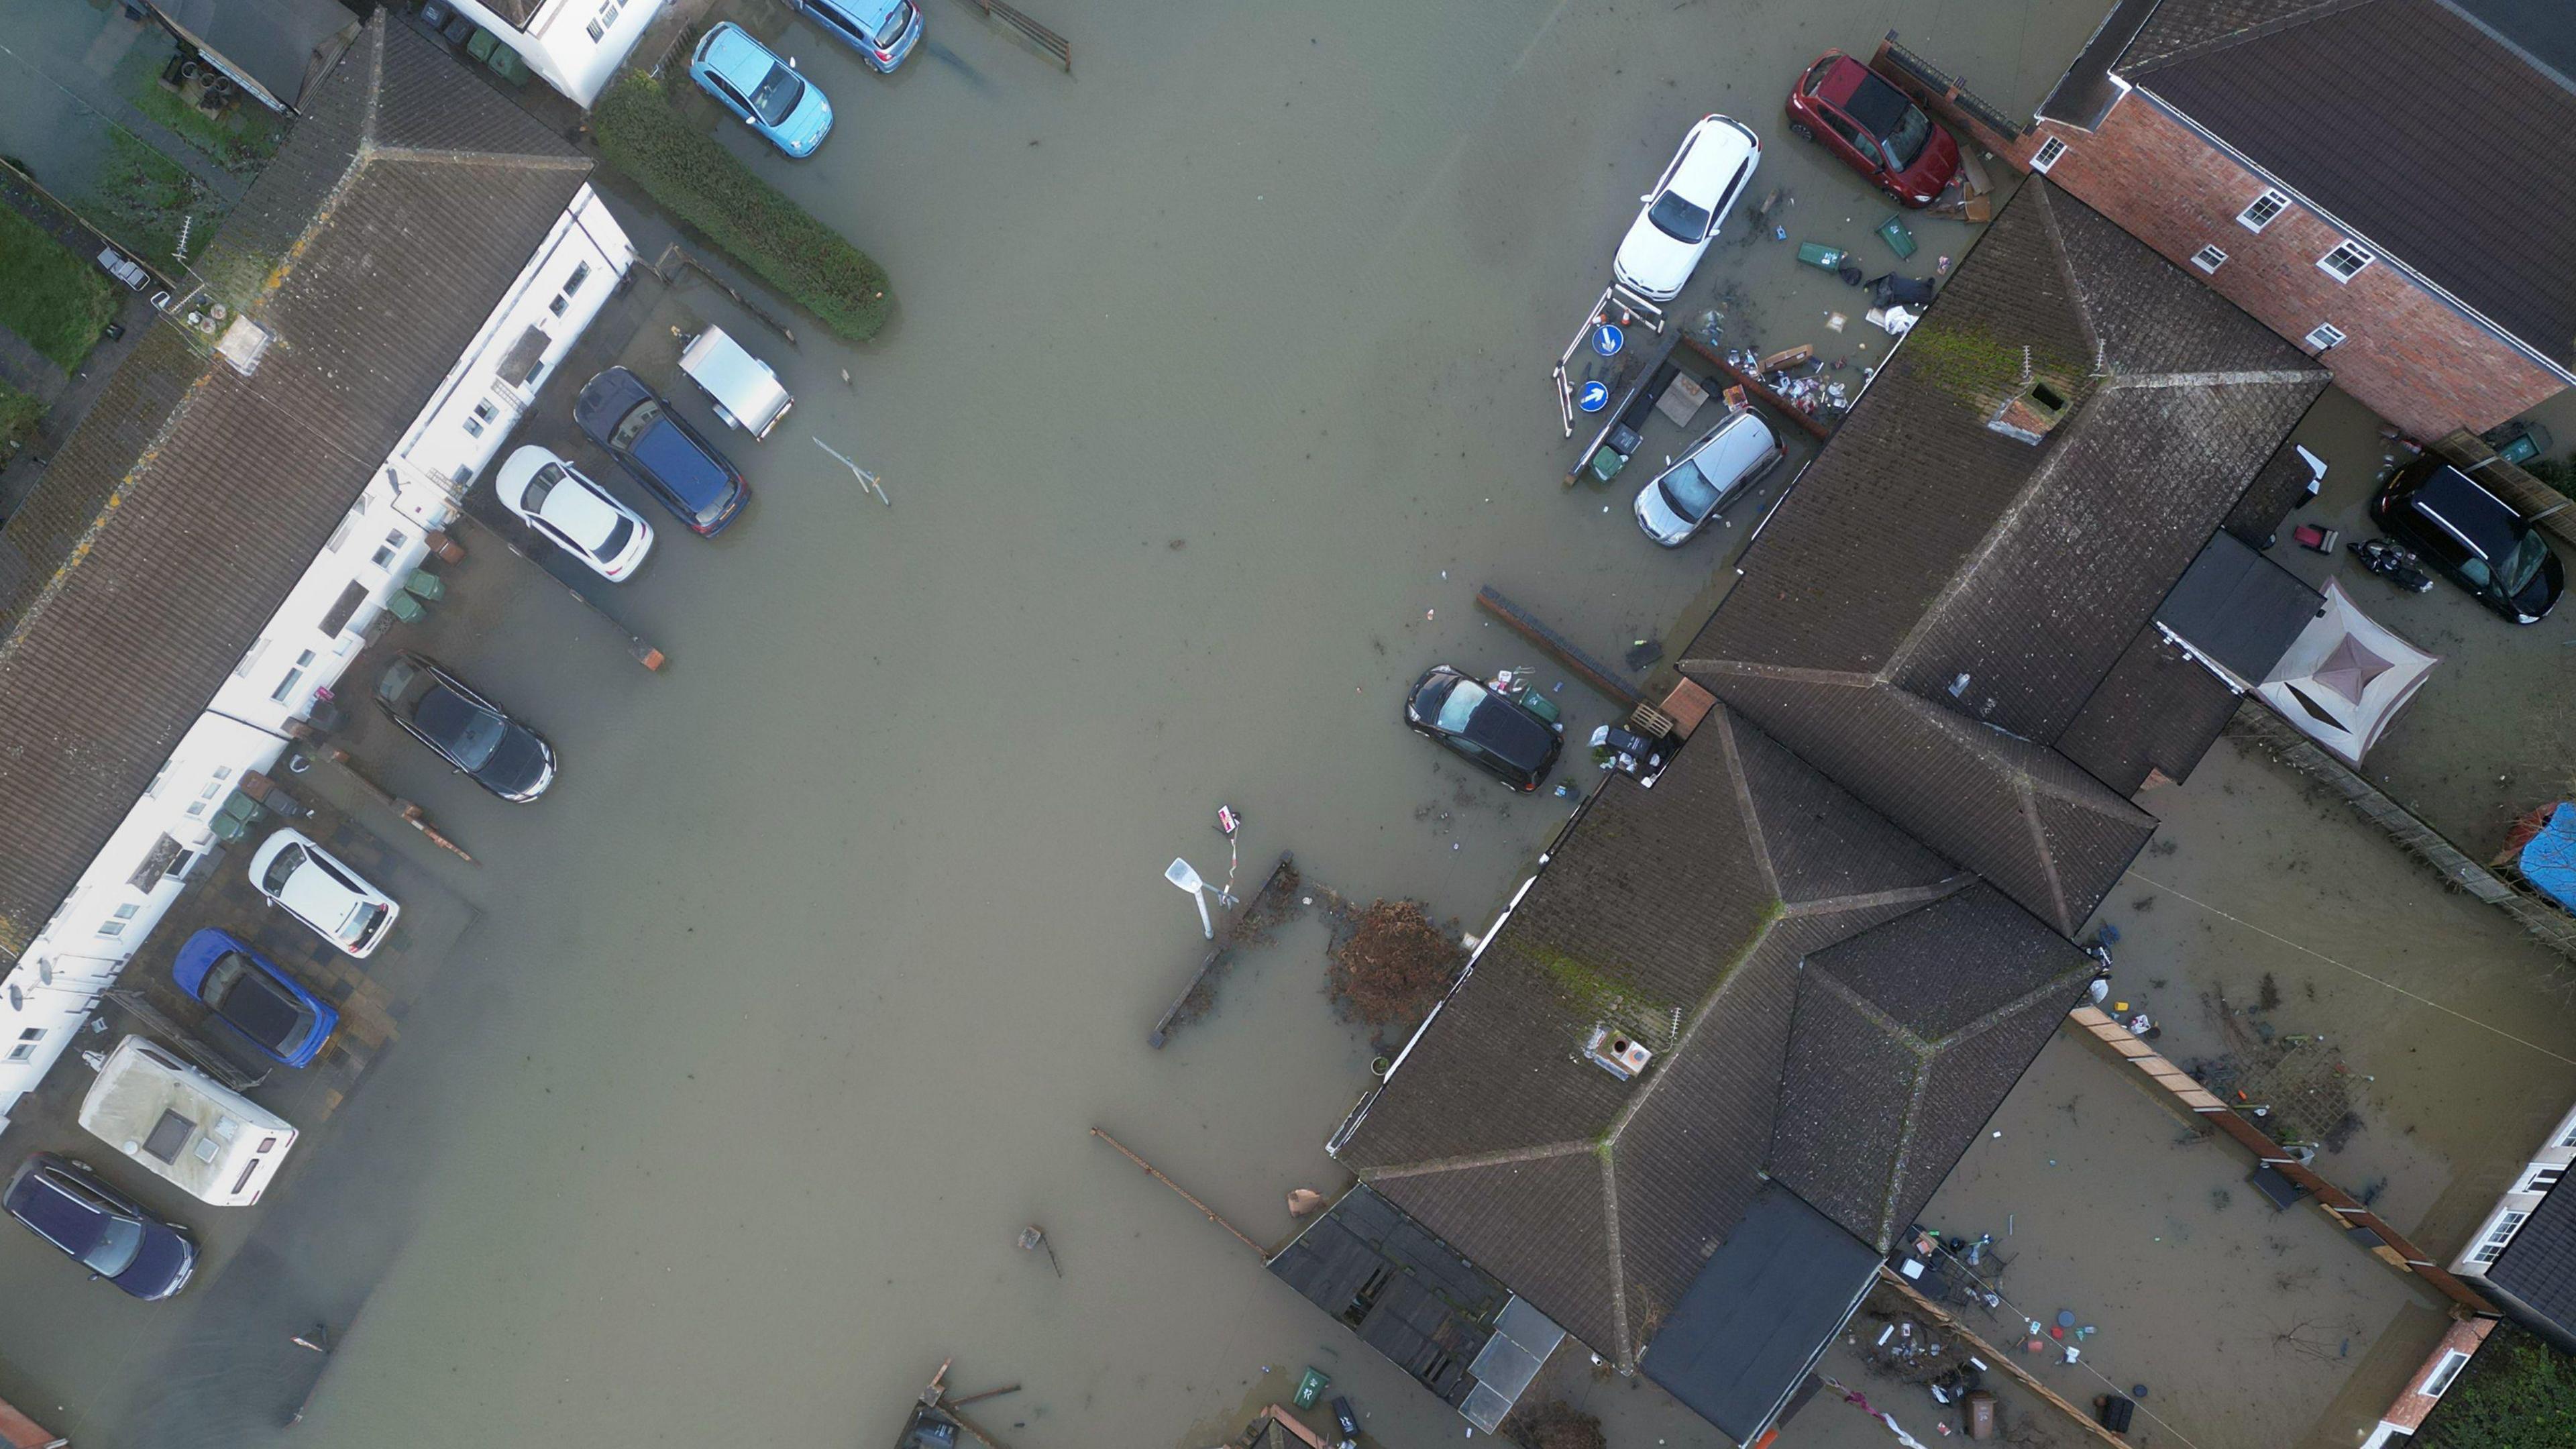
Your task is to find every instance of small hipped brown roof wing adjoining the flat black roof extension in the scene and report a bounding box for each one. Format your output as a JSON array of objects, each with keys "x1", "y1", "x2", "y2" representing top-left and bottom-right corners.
[{"x1": 1770, "y1": 884, "x2": 2094, "y2": 1253}]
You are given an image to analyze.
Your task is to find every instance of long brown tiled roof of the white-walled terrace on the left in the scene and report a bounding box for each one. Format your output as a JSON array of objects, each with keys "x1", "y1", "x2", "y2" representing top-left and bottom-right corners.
[{"x1": 0, "y1": 13, "x2": 588, "y2": 957}]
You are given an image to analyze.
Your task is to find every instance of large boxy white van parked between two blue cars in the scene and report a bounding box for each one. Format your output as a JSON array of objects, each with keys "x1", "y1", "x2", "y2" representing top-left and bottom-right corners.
[{"x1": 80, "y1": 1036, "x2": 297, "y2": 1207}]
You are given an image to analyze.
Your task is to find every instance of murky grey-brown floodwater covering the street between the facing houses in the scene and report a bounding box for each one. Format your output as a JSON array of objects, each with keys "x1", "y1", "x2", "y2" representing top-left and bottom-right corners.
[{"x1": 8, "y1": 0, "x2": 2143, "y2": 1449}]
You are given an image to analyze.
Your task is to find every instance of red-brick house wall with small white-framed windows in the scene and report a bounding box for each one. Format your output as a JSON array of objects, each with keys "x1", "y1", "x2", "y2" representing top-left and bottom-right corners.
[{"x1": 2006, "y1": 93, "x2": 2566, "y2": 438}]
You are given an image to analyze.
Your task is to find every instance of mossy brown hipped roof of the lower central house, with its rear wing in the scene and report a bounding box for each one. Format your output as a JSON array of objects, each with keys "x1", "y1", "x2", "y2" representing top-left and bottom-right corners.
[{"x1": 1334, "y1": 709, "x2": 2084, "y2": 1361}]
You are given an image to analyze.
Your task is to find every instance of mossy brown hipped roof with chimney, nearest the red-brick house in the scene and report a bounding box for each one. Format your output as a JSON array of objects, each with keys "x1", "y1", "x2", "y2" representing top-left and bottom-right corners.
[{"x1": 1682, "y1": 178, "x2": 2326, "y2": 936}]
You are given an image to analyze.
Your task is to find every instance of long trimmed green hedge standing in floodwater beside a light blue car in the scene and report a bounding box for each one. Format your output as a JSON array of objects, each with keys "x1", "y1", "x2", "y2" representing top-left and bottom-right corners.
[{"x1": 590, "y1": 70, "x2": 894, "y2": 343}]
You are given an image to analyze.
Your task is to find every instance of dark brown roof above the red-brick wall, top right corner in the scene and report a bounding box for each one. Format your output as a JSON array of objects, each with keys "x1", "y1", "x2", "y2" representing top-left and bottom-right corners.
[{"x1": 2123, "y1": 0, "x2": 2576, "y2": 366}]
